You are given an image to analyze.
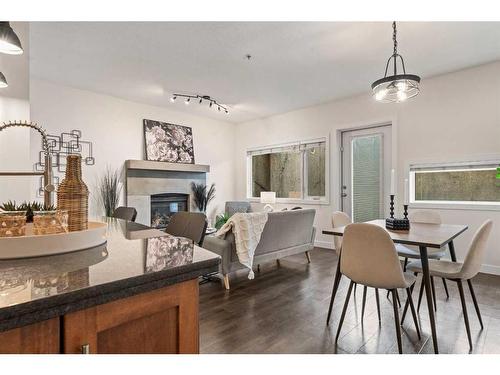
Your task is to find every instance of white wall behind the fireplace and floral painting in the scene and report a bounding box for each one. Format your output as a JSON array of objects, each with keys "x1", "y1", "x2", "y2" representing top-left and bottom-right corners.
[{"x1": 30, "y1": 78, "x2": 235, "y2": 223}]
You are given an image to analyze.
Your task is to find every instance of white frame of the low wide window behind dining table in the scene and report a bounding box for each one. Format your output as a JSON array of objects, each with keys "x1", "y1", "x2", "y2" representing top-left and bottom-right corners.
[{"x1": 407, "y1": 157, "x2": 500, "y2": 211}]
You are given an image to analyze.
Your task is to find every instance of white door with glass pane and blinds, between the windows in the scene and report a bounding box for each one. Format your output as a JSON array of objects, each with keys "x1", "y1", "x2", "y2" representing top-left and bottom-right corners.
[{"x1": 341, "y1": 125, "x2": 392, "y2": 222}]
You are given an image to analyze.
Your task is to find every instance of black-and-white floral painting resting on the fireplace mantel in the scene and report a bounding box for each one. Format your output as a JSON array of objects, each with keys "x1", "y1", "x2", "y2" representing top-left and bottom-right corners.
[{"x1": 144, "y1": 120, "x2": 194, "y2": 164}]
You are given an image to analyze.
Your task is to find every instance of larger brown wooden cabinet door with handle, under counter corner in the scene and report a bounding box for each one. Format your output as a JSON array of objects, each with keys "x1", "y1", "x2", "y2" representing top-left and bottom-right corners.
[{"x1": 63, "y1": 279, "x2": 199, "y2": 354}]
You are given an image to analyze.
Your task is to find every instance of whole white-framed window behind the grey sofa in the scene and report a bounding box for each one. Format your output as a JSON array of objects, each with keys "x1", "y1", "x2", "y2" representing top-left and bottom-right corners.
[{"x1": 247, "y1": 139, "x2": 326, "y2": 200}]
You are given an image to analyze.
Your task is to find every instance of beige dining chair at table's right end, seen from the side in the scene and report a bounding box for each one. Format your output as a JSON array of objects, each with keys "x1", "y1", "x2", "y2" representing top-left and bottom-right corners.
[{"x1": 406, "y1": 220, "x2": 493, "y2": 350}]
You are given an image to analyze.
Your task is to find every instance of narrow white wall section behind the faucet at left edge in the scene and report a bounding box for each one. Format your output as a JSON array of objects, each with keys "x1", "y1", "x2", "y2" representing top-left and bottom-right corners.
[{"x1": 0, "y1": 96, "x2": 35, "y2": 203}]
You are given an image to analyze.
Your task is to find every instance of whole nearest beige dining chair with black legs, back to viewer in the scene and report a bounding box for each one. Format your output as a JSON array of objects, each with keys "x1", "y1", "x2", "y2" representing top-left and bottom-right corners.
[{"x1": 335, "y1": 223, "x2": 421, "y2": 354}]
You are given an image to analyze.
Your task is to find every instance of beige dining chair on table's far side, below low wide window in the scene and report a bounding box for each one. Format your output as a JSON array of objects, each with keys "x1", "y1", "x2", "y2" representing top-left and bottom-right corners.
[{"x1": 396, "y1": 210, "x2": 450, "y2": 311}]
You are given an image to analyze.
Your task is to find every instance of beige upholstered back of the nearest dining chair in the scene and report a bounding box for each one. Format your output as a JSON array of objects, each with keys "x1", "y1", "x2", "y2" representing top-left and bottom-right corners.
[{"x1": 340, "y1": 223, "x2": 406, "y2": 289}]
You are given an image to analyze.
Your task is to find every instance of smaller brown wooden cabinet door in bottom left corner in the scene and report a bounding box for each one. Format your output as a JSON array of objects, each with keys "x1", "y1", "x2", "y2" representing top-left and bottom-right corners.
[{"x1": 0, "y1": 318, "x2": 60, "y2": 354}]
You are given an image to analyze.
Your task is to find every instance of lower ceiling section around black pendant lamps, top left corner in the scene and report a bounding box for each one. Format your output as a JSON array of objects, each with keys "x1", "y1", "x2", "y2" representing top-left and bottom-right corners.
[{"x1": 0, "y1": 22, "x2": 30, "y2": 100}]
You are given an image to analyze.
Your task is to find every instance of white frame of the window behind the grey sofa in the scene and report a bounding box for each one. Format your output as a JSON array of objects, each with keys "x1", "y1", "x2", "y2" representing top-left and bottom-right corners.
[{"x1": 245, "y1": 136, "x2": 330, "y2": 205}]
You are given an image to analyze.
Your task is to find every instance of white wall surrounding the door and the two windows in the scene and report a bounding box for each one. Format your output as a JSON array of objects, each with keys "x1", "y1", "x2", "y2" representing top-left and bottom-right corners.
[{"x1": 235, "y1": 62, "x2": 500, "y2": 274}]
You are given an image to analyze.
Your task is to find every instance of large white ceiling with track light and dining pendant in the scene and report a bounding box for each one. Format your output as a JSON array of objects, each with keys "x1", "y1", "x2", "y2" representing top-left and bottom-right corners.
[{"x1": 30, "y1": 22, "x2": 500, "y2": 122}]
